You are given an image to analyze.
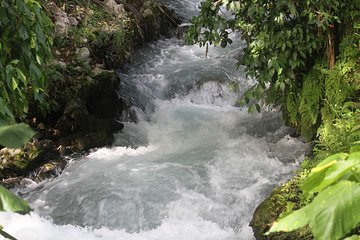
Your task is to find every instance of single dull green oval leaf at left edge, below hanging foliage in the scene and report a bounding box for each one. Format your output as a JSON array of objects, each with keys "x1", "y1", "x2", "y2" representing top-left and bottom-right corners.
[{"x1": 0, "y1": 123, "x2": 35, "y2": 148}]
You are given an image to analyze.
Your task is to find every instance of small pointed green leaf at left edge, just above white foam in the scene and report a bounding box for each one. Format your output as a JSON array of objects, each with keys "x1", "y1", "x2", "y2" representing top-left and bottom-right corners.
[{"x1": 0, "y1": 185, "x2": 31, "y2": 214}]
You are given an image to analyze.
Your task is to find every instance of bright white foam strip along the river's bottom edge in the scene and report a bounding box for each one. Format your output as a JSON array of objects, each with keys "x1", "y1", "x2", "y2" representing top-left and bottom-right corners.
[{"x1": 0, "y1": 213, "x2": 233, "y2": 240}]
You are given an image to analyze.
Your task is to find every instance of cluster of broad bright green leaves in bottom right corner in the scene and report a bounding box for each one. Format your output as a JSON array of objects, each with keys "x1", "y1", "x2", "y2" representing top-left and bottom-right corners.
[{"x1": 267, "y1": 147, "x2": 360, "y2": 240}]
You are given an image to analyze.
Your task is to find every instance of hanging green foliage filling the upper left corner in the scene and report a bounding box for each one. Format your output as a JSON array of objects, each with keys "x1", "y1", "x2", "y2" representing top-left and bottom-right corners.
[{"x1": 0, "y1": 0, "x2": 52, "y2": 125}]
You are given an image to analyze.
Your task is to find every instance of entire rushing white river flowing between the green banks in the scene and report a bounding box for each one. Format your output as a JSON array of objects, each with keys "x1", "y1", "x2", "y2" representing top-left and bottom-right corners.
[{"x1": 0, "y1": 0, "x2": 305, "y2": 240}]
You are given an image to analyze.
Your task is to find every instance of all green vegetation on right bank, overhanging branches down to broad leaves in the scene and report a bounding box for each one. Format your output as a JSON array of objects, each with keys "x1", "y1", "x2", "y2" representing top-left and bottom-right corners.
[{"x1": 188, "y1": 0, "x2": 360, "y2": 239}]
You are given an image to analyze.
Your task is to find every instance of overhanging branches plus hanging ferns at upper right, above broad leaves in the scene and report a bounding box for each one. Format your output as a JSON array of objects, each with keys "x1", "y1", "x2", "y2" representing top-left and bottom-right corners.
[{"x1": 187, "y1": 0, "x2": 359, "y2": 140}]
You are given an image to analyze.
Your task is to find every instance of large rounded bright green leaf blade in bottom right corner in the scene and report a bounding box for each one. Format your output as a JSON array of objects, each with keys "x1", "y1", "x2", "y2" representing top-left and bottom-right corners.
[{"x1": 307, "y1": 181, "x2": 360, "y2": 240}]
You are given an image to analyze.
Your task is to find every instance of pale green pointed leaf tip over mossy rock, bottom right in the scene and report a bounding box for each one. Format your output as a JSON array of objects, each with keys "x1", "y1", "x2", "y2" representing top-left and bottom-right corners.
[{"x1": 266, "y1": 204, "x2": 310, "y2": 235}]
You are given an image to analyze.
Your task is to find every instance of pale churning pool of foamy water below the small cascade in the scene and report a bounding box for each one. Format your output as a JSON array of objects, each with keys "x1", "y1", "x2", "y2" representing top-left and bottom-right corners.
[{"x1": 0, "y1": 99, "x2": 304, "y2": 240}]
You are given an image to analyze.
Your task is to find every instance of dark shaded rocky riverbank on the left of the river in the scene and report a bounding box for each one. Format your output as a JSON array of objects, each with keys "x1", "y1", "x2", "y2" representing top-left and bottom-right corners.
[{"x1": 0, "y1": 0, "x2": 181, "y2": 186}]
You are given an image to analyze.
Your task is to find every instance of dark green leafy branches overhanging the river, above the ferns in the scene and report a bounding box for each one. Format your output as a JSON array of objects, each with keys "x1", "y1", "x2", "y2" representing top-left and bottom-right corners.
[{"x1": 189, "y1": 0, "x2": 353, "y2": 92}]
